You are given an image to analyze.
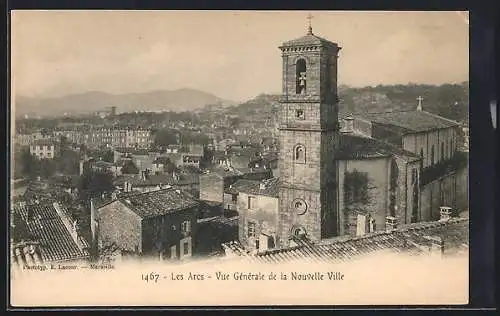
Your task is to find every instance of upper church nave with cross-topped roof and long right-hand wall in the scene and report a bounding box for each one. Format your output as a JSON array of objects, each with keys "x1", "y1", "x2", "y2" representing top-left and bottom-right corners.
[{"x1": 342, "y1": 103, "x2": 468, "y2": 221}]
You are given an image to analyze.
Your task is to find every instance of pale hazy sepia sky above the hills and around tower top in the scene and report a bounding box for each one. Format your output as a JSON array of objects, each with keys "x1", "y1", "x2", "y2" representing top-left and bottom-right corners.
[{"x1": 11, "y1": 10, "x2": 469, "y2": 101}]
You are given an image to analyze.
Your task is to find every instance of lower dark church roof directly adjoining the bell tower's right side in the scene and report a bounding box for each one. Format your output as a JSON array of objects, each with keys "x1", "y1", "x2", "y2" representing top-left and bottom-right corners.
[{"x1": 336, "y1": 134, "x2": 420, "y2": 160}]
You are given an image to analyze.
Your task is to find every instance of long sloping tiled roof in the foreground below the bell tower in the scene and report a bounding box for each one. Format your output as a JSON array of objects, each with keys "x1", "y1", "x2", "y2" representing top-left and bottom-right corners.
[{"x1": 224, "y1": 218, "x2": 469, "y2": 263}]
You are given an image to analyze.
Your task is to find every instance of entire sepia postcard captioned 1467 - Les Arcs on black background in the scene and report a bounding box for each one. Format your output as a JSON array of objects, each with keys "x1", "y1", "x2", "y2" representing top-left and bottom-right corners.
[{"x1": 8, "y1": 10, "x2": 470, "y2": 307}]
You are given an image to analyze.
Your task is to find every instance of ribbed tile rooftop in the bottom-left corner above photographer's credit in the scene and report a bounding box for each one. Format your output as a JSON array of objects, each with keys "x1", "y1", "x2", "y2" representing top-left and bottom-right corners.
[{"x1": 11, "y1": 204, "x2": 89, "y2": 265}]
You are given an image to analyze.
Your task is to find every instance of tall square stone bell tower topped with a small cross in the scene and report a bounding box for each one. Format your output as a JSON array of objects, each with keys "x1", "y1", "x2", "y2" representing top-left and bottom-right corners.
[{"x1": 278, "y1": 19, "x2": 341, "y2": 247}]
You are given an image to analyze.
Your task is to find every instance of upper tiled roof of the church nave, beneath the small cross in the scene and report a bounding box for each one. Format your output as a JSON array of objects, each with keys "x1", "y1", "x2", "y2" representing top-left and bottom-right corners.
[{"x1": 354, "y1": 111, "x2": 459, "y2": 132}]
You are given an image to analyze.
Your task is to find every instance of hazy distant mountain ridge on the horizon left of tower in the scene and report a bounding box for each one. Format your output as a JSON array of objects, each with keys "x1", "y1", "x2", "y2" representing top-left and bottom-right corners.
[{"x1": 15, "y1": 88, "x2": 236, "y2": 116}]
